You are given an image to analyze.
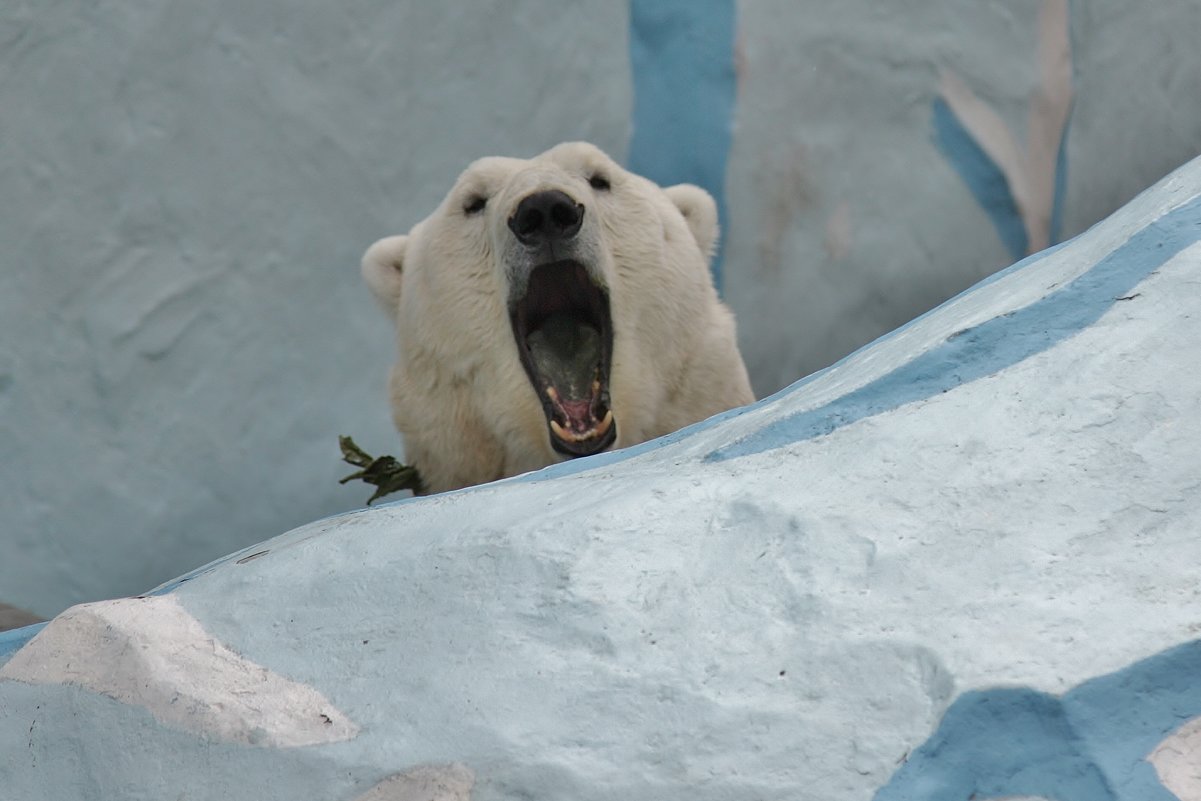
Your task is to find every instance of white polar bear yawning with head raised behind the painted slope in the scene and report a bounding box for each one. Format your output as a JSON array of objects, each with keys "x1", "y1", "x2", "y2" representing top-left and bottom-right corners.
[{"x1": 362, "y1": 142, "x2": 754, "y2": 492}]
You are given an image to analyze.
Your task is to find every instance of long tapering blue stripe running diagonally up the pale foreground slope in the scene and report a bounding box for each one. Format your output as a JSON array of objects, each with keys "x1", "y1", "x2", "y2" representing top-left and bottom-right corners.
[{"x1": 707, "y1": 198, "x2": 1201, "y2": 460}]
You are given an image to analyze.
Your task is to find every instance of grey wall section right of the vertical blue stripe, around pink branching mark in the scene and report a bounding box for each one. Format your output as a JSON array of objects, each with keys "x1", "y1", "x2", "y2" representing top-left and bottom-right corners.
[{"x1": 725, "y1": 0, "x2": 1201, "y2": 393}]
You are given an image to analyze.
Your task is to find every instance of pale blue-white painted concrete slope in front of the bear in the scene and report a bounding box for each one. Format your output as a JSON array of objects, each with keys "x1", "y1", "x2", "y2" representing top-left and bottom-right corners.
[{"x1": 0, "y1": 154, "x2": 1201, "y2": 801}]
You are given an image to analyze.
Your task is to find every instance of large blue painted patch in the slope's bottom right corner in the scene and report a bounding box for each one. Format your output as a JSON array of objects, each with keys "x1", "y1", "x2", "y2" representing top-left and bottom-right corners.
[{"x1": 876, "y1": 641, "x2": 1201, "y2": 801}]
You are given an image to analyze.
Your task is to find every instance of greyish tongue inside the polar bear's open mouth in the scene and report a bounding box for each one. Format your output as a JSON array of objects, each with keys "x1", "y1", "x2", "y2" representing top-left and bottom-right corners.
[{"x1": 526, "y1": 315, "x2": 601, "y2": 403}]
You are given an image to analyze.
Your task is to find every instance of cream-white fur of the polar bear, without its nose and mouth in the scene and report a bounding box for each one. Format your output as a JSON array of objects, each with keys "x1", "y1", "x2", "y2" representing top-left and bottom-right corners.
[{"x1": 363, "y1": 143, "x2": 753, "y2": 492}]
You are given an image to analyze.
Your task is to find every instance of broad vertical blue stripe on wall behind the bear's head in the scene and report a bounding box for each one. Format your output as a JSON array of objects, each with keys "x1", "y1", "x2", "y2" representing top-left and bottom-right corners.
[{"x1": 628, "y1": 0, "x2": 737, "y2": 288}]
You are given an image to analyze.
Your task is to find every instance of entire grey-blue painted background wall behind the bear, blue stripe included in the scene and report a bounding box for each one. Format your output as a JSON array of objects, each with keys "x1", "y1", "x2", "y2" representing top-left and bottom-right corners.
[{"x1": 0, "y1": 0, "x2": 1201, "y2": 629}]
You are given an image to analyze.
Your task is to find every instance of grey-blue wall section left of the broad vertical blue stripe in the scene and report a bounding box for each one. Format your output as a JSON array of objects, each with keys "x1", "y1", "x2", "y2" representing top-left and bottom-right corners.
[{"x1": 0, "y1": 0, "x2": 632, "y2": 615}]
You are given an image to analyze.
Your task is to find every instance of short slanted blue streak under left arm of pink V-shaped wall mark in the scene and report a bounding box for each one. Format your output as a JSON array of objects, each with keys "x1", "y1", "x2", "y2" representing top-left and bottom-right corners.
[{"x1": 932, "y1": 97, "x2": 1029, "y2": 259}]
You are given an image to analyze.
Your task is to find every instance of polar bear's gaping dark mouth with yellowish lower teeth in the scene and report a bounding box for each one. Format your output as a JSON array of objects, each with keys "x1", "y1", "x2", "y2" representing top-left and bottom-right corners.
[{"x1": 509, "y1": 261, "x2": 617, "y2": 456}]
